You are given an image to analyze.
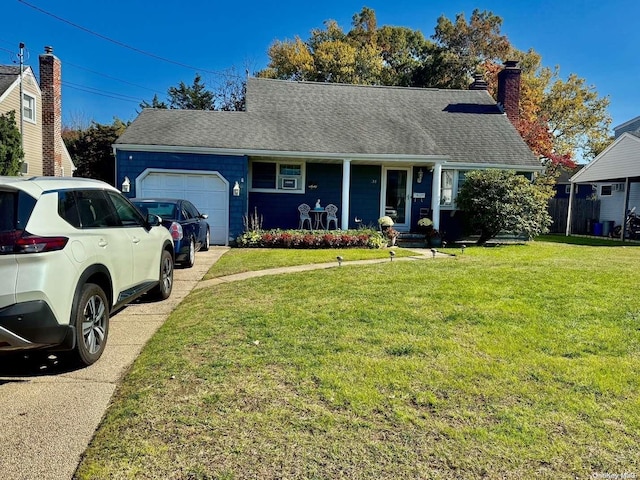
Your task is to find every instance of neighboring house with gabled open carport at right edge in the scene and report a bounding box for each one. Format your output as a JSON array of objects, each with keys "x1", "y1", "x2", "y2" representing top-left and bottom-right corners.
[{"x1": 566, "y1": 117, "x2": 640, "y2": 235}]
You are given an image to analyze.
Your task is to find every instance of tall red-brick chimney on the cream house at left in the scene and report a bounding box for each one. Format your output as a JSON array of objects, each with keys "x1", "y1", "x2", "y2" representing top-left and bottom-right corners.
[{"x1": 40, "y1": 47, "x2": 63, "y2": 177}]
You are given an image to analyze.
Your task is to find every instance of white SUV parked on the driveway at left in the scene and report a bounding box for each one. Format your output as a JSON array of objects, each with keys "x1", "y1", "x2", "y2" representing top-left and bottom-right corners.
[{"x1": 0, "y1": 177, "x2": 173, "y2": 365}]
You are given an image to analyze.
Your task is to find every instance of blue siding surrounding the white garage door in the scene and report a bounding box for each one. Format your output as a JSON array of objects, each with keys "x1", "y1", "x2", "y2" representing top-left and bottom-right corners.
[{"x1": 116, "y1": 150, "x2": 249, "y2": 238}]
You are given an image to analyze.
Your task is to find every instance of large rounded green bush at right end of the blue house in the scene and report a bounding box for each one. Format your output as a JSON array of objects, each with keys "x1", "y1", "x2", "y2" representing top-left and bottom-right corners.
[{"x1": 456, "y1": 170, "x2": 553, "y2": 245}]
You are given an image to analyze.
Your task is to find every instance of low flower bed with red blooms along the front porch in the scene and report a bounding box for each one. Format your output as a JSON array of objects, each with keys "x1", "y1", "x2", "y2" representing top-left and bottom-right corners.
[{"x1": 236, "y1": 229, "x2": 387, "y2": 248}]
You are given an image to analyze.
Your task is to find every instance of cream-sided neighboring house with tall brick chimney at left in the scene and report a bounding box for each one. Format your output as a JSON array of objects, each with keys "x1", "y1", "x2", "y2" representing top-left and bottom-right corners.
[{"x1": 0, "y1": 47, "x2": 75, "y2": 176}]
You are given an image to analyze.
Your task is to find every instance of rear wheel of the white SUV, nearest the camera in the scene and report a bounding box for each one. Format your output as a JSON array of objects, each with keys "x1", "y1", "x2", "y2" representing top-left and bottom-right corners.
[{"x1": 72, "y1": 283, "x2": 109, "y2": 366}]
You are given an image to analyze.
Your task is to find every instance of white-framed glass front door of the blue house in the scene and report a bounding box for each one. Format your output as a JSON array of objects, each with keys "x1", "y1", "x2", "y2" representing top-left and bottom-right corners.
[{"x1": 380, "y1": 168, "x2": 411, "y2": 231}]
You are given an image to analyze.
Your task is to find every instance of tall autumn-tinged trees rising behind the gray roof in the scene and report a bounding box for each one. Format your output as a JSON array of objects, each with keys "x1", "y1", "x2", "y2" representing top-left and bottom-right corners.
[{"x1": 258, "y1": 8, "x2": 611, "y2": 166}]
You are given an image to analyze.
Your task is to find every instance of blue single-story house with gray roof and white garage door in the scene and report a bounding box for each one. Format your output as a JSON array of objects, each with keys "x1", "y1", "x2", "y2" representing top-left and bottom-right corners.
[{"x1": 114, "y1": 62, "x2": 541, "y2": 244}]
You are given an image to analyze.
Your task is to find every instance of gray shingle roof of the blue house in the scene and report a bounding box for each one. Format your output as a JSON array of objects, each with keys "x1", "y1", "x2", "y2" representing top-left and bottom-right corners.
[{"x1": 116, "y1": 78, "x2": 540, "y2": 167}]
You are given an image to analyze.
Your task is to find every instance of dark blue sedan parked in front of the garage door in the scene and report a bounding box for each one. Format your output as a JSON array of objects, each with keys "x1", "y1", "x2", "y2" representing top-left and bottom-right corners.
[{"x1": 131, "y1": 198, "x2": 211, "y2": 267}]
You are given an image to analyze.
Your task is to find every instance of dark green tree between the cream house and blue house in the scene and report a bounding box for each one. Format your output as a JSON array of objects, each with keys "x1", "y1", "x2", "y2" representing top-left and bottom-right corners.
[{"x1": 63, "y1": 118, "x2": 127, "y2": 186}]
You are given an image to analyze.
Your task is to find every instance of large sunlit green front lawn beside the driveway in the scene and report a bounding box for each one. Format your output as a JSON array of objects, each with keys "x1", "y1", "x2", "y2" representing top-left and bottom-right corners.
[{"x1": 78, "y1": 242, "x2": 640, "y2": 479}]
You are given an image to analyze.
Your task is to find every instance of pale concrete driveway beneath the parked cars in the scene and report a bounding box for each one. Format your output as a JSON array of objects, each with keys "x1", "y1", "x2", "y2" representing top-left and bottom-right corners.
[{"x1": 0, "y1": 247, "x2": 227, "y2": 480}]
